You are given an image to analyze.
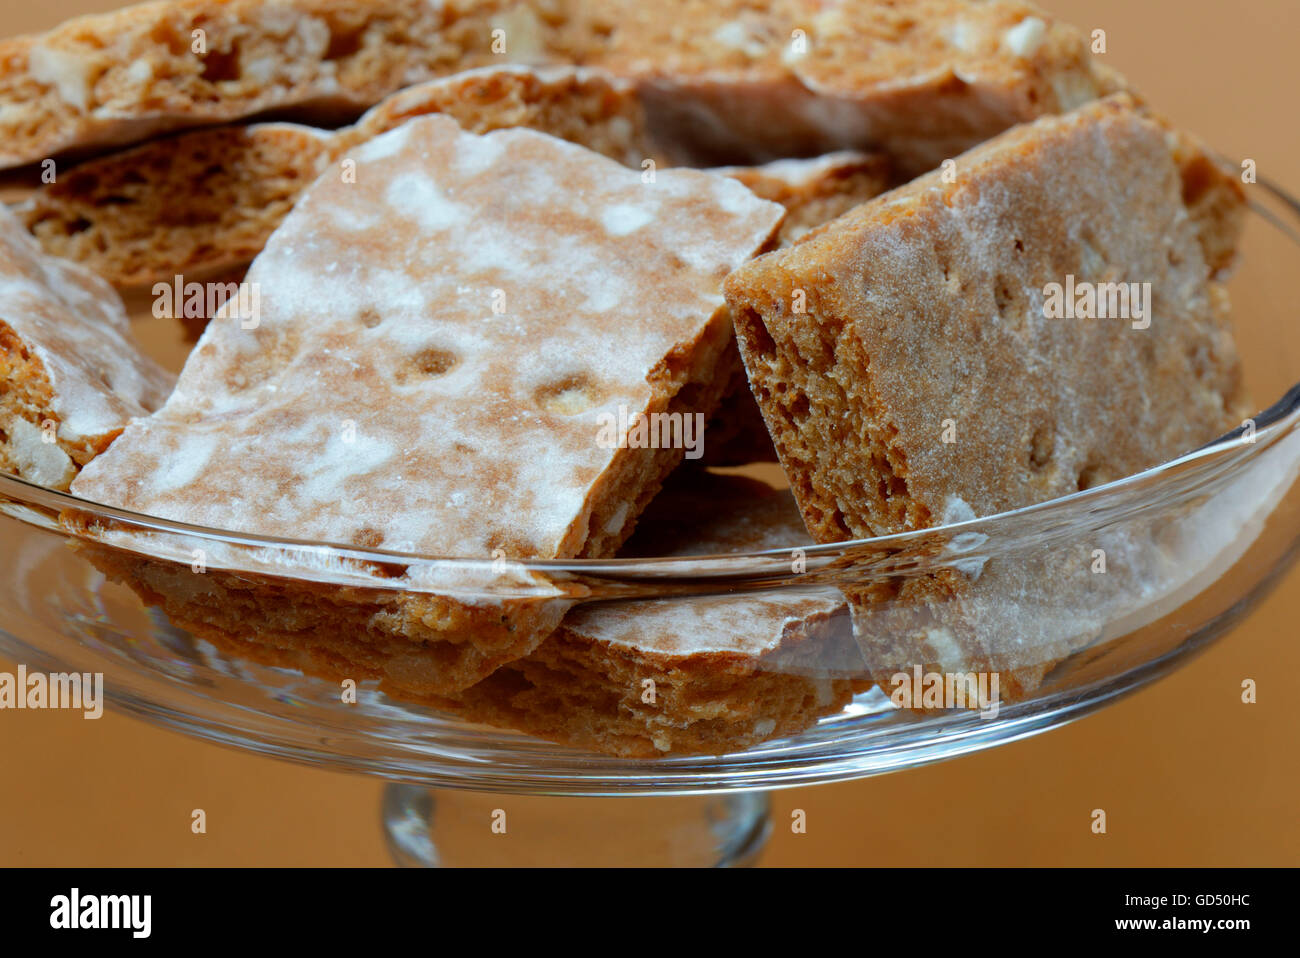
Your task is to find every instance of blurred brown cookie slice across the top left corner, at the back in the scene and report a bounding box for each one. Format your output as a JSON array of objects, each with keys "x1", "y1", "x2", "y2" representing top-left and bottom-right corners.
[{"x1": 0, "y1": 0, "x2": 586, "y2": 168}]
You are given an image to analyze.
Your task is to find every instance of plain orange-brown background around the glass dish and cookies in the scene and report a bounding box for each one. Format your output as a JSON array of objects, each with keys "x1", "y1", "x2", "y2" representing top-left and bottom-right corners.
[{"x1": 0, "y1": 0, "x2": 1300, "y2": 866}]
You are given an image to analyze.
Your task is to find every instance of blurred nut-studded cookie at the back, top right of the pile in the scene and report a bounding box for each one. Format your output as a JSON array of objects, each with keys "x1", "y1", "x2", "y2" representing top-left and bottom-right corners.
[{"x1": 599, "y1": 0, "x2": 1123, "y2": 175}]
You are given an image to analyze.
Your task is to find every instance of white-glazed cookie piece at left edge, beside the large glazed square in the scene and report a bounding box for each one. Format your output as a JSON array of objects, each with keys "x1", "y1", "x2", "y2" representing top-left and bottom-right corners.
[{"x1": 0, "y1": 207, "x2": 173, "y2": 489}]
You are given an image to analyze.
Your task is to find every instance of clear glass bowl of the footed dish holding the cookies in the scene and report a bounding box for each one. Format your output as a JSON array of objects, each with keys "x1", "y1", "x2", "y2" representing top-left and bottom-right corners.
[{"x1": 0, "y1": 185, "x2": 1300, "y2": 796}]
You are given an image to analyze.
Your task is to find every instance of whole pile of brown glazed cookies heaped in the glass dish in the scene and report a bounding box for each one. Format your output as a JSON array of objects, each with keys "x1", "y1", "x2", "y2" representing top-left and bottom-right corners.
[{"x1": 0, "y1": 0, "x2": 1248, "y2": 757}]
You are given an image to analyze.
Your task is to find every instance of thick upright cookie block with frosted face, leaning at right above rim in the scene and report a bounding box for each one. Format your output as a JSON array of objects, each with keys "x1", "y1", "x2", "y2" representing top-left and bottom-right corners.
[{"x1": 727, "y1": 95, "x2": 1245, "y2": 696}]
